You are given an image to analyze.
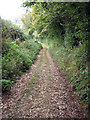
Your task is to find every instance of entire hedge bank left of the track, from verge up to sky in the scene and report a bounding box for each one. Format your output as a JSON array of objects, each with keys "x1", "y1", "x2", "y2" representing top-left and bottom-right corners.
[{"x1": 0, "y1": 19, "x2": 42, "y2": 91}]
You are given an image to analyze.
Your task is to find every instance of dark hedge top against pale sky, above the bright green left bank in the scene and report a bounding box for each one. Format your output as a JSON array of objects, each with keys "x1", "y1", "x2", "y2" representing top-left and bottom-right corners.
[{"x1": 1, "y1": 19, "x2": 27, "y2": 41}]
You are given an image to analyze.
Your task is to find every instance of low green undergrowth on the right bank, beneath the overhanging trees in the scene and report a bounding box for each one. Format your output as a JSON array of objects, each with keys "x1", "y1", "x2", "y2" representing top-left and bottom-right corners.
[{"x1": 49, "y1": 44, "x2": 90, "y2": 110}]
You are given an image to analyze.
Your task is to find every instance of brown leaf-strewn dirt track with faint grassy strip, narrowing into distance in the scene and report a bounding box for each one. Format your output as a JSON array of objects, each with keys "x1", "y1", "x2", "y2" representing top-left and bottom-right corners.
[{"x1": 2, "y1": 48, "x2": 87, "y2": 119}]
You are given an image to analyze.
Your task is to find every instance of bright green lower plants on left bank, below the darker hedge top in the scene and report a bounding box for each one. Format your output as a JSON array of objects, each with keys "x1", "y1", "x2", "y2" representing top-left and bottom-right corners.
[{"x1": 2, "y1": 40, "x2": 41, "y2": 89}]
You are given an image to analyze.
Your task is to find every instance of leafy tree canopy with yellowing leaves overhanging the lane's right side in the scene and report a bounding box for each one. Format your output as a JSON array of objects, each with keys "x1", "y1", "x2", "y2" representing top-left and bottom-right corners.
[{"x1": 22, "y1": 1, "x2": 89, "y2": 48}]
